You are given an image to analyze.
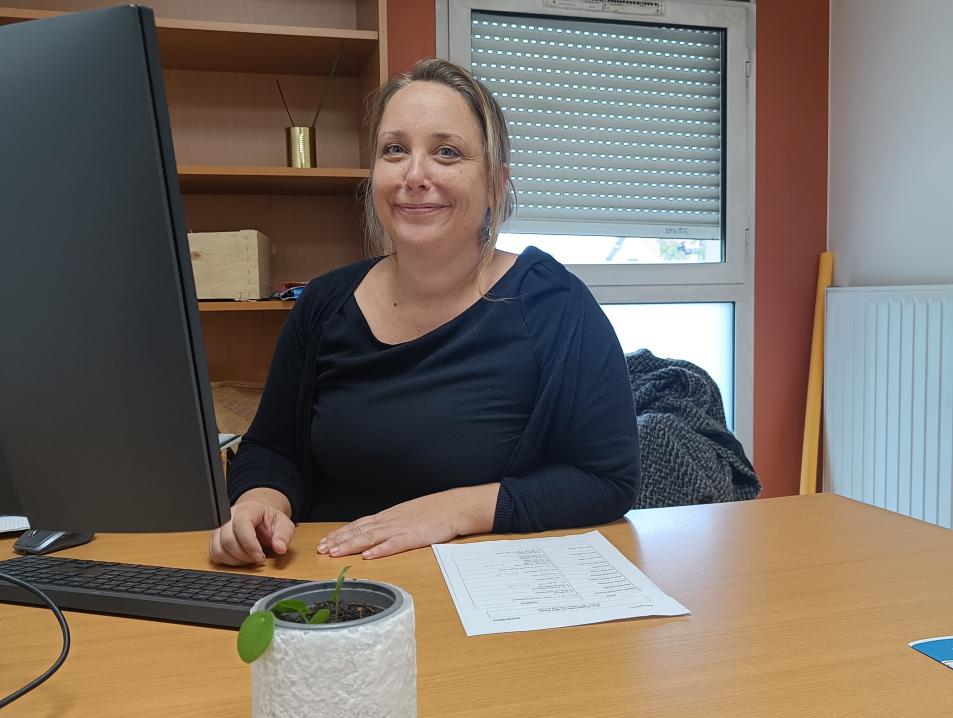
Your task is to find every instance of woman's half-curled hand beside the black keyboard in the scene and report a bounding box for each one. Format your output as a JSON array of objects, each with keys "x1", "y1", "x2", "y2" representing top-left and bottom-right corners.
[{"x1": 208, "y1": 488, "x2": 295, "y2": 566}]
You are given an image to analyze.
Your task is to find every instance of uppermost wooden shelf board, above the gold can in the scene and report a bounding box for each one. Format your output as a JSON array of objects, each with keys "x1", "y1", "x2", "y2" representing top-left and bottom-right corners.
[{"x1": 0, "y1": 7, "x2": 378, "y2": 77}]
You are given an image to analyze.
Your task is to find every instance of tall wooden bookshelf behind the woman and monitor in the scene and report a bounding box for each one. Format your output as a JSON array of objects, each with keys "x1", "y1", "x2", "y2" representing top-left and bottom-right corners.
[{"x1": 0, "y1": 0, "x2": 387, "y2": 383}]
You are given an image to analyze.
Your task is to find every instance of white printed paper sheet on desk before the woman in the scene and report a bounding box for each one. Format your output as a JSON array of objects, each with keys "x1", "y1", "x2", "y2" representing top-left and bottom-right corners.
[{"x1": 433, "y1": 531, "x2": 689, "y2": 636}]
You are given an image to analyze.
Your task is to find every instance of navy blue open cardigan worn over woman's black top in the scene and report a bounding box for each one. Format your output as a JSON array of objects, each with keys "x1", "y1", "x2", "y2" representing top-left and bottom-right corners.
[{"x1": 228, "y1": 247, "x2": 639, "y2": 532}]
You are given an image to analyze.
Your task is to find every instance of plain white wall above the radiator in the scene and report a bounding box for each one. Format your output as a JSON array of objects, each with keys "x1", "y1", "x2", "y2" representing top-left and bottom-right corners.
[{"x1": 828, "y1": 0, "x2": 953, "y2": 286}]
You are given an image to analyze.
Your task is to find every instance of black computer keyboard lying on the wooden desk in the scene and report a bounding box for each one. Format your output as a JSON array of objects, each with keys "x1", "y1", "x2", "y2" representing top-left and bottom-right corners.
[{"x1": 0, "y1": 556, "x2": 306, "y2": 628}]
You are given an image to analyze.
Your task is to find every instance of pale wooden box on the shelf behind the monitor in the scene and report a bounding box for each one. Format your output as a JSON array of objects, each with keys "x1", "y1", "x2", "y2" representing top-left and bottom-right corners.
[{"x1": 188, "y1": 229, "x2": 271, "y2": 299}]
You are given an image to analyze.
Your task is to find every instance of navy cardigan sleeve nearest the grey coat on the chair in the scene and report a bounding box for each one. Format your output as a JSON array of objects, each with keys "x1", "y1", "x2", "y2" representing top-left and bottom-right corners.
[{"x1": 493, "y1": 261, "x2": 640, "y2": 532}]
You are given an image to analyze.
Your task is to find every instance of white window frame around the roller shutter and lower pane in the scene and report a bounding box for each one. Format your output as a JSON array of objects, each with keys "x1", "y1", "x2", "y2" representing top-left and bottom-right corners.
[{"x1": 435, "y1": 0, "x2": 755, "y2": 456}]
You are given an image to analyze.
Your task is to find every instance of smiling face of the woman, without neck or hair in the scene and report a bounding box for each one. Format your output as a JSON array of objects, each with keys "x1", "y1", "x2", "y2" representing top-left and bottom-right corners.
[{"x1": 372, "y1": 82, "x2": 489, "y2": 251}]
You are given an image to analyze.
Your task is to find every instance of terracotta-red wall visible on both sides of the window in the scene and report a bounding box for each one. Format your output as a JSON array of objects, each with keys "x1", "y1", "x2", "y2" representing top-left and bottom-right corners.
[{"x1": 387, "y1": 0, "x2": 829, "y2": 497}]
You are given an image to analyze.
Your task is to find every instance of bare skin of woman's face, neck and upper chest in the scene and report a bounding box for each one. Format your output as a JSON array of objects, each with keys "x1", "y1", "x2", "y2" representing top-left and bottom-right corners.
[{"x1": 355, "y1": 81, "x2": 516, "y2": 344}]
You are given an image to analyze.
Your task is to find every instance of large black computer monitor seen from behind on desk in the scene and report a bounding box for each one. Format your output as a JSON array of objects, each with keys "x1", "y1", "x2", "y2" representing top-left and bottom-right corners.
[{"x1": 0, "y1": 6, "x2": 229, "y2": 531}]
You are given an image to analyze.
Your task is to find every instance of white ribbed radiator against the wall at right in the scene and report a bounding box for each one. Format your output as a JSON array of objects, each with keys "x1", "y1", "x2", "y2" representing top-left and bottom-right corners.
[{"x1": 823, "y1": 285, "x2": 953, "y2": 528}]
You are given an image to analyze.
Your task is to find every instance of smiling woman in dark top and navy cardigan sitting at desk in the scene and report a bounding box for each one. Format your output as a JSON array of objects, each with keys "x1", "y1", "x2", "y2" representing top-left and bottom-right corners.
[{"x1": 209, "y1": 60, "x2": 639, "y2": 565}]
